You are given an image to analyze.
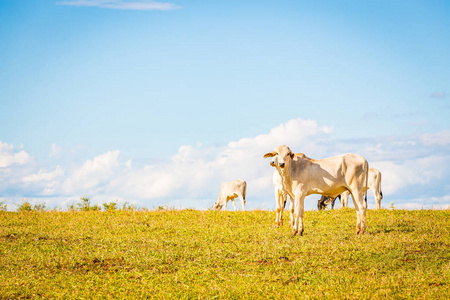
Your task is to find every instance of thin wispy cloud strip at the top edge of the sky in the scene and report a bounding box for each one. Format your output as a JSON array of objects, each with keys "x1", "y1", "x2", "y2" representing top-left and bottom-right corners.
[{"x1": 57, "y1": 0, "x2": 181, "y2": 10}]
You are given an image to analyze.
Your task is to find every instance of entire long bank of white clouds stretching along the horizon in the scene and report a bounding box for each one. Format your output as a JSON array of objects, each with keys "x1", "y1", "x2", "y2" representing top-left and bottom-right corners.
[{"x1": 0, "y1": 119, "x2": 450, "y2": 209}]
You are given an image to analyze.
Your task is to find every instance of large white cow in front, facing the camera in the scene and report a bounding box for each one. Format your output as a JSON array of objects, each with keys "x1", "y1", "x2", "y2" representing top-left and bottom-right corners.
[{"x1": 264, "y1": 145, "x2": 369, "y2": 235}]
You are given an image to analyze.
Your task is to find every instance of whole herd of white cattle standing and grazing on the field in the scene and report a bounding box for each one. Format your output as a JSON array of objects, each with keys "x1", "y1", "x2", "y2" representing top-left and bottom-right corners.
[{"x1": 214, "y1": 145, "x2": 383, "y2": 235}]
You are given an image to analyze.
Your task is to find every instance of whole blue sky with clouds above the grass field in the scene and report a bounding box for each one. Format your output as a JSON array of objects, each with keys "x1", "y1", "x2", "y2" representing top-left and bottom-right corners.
[{"x1": 0, "y1": 0, "x2": 450, "y2": 210}]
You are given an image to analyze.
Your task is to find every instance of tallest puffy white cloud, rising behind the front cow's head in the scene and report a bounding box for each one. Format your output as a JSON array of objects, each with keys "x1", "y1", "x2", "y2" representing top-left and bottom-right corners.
[{"x1": 114, "y1": 119, "x2": 331, "y2": 203}]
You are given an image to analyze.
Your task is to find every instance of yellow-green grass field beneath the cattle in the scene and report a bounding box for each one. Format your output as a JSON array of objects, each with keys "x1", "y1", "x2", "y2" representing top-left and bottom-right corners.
[{"x1": 0, "y1": 209, "x2": 450, "y2": 299}]
